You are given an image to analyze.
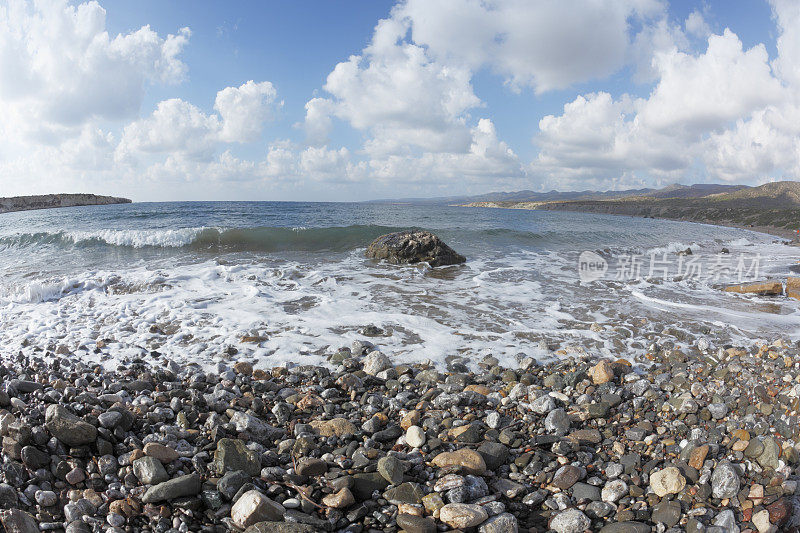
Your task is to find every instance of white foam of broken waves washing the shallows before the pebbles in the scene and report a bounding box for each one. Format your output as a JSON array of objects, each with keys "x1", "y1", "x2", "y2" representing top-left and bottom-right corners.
[{"x1": 0, "y1": 212, "x2": 800, "y2": 367}]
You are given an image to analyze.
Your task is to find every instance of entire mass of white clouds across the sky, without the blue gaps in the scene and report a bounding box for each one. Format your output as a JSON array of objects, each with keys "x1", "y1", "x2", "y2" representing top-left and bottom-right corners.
[{"x1": 0, "y1": 0, "x2": 800, "y2": 196}]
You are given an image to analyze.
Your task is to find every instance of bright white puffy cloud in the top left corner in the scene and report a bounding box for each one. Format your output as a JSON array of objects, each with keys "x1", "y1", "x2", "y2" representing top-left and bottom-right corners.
[{"x1": 0, "y1": 0, "x2": 190, "y2": 135}]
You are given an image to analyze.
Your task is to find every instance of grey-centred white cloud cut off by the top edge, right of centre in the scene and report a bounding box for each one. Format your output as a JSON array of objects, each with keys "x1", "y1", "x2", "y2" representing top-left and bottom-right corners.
[{"x1": 393, "y1": 0, "x2": 665, "y2": 92}]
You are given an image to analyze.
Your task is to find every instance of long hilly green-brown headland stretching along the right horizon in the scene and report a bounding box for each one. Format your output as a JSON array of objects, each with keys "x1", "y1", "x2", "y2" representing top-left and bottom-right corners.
[{"x1": 459, "y1": 181, "x2": 800, "y2": 243}]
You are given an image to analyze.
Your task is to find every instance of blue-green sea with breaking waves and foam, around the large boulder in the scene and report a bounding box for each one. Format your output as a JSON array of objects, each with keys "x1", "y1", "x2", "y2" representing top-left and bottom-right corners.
[{"x1": 0, "y1": 202, "x2": 800, "y2": 368}]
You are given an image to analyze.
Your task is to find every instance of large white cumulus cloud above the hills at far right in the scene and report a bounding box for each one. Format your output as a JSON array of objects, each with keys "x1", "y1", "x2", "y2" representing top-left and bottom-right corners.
[{"x1": 530, "y1": 10, "x2": 800, "y2": 187}]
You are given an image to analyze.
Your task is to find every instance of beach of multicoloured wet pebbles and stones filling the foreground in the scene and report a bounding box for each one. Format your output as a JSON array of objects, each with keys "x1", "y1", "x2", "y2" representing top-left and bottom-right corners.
[{"x1": 0, "y1": 339, "x2": 800, "y2": 533}]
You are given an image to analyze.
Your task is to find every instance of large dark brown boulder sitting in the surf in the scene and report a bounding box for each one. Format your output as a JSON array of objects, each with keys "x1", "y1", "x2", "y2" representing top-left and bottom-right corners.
[{"x1": 367, "y1": 230, "x2": 466, "y2": 267}]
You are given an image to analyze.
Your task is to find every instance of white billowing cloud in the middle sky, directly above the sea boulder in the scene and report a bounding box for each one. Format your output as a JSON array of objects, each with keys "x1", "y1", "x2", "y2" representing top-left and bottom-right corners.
[{"x1": 306, "y1": 14, "x2": 481, "y2": 155}]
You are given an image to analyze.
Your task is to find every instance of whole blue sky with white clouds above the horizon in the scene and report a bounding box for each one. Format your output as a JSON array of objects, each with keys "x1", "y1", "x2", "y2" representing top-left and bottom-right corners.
[{"x1": 0, "y1": 0, "x2": 800, "y2": 201}]
